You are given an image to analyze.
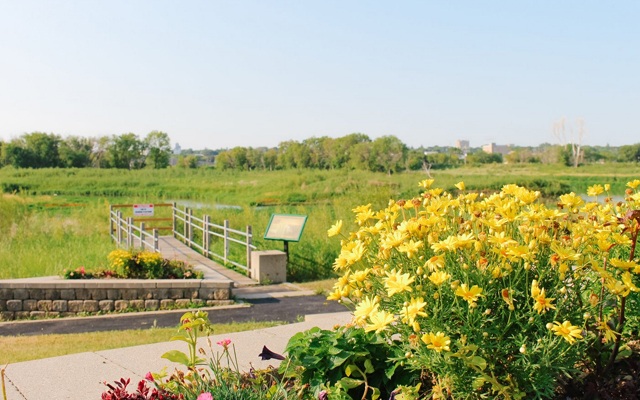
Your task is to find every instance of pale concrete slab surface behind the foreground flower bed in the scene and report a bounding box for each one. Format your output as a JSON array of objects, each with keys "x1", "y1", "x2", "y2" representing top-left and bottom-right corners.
[{"x1": 5, "y1": 312, "x2": 351, "y2": 400}]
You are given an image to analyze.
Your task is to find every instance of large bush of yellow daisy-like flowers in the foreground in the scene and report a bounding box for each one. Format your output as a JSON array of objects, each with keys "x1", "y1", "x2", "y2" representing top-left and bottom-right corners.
[{"x1": 328, "y1": 180, "x2": 640, "y2": 399}]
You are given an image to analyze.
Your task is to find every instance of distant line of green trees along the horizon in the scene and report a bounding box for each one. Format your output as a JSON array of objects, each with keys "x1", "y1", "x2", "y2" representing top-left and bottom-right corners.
[{"x1": 0, "y1": 131, "x2": 640, "y2": 170}]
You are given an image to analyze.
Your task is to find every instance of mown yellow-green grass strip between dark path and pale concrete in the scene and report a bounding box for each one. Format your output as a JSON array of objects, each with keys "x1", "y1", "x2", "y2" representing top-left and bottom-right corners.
[{"x1": 0, "y1": 321, "x2": 284, "y2": 365}]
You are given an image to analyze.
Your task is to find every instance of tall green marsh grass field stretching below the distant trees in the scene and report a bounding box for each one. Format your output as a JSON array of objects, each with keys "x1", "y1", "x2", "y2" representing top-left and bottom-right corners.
[{"x1": 0, "y1": 164, "x2": 640, "y2": 281}]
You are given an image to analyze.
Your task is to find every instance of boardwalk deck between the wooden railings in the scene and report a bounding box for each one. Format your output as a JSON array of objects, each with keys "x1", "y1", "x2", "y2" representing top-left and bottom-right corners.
[{"x1": 158, "y1": 236, "x2": 258, "y2": 287}]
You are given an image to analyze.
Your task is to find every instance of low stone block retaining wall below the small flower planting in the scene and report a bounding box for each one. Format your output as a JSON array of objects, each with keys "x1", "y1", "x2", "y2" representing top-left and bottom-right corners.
[{"x1": 0, "y1": 279, "x2": 233, "y2": 321}]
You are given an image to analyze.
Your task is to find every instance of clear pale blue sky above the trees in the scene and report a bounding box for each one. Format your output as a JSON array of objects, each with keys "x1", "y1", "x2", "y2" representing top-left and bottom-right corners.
[{"x1": 0, "y1": 0, "x2": 640, "y2": 149}]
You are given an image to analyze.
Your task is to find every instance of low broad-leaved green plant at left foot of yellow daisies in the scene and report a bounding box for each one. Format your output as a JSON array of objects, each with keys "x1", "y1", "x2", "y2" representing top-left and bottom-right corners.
[{"x1": 280, "y1": 327, "x2": 417, "y2": 399}]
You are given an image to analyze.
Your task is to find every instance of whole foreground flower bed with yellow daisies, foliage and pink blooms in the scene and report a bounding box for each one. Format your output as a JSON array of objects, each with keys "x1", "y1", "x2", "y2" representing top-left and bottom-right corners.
[{"x1": 103, "y1": 180, "x2": 640, "y2": 400}]
